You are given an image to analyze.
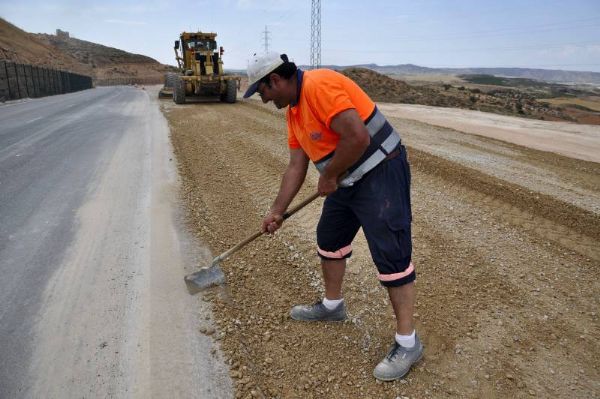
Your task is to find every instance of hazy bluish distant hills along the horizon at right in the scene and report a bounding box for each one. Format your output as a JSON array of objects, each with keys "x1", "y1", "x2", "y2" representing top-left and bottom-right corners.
[{"x1": 308, "y1": 64, "x2": 600, "y2": 85}]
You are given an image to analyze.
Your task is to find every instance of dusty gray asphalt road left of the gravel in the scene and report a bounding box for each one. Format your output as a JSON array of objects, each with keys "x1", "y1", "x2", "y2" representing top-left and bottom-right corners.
[{"x1": 0, "y1": 87, "x2": 231, "y2": 398}]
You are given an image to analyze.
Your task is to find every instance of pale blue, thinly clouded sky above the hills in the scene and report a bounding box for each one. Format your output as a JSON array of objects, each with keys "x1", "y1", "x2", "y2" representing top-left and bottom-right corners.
[{"x1": 0, "y1": 0, "x2": 600, "y2": 72}]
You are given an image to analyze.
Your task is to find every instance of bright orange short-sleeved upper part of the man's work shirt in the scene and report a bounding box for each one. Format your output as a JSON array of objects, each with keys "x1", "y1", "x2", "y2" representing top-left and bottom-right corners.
[{"x1": 287, "y1": 69, "x2": 375, "y2": 162}]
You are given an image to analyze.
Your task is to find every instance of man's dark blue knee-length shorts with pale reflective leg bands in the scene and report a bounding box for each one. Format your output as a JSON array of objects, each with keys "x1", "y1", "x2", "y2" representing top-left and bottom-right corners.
[{"x1": 317, "y1": 146, "x2": 416, "y2": 287}]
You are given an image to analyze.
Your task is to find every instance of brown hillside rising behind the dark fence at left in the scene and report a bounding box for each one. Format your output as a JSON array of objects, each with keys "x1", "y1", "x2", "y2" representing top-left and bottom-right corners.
[{"x1": 0, "y1": 18, "x2": 172, "y2": 82}]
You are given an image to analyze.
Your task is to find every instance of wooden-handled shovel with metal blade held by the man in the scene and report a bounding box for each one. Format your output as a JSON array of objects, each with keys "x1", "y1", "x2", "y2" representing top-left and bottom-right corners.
[{"x1": 185, "y1": 193, "x2": 319, "y2": 294}]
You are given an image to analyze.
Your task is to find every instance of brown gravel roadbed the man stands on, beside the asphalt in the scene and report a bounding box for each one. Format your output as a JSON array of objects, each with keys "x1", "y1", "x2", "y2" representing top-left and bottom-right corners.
[{"x1": 163, "y1": 100, "x2": 600, "y2": 398}]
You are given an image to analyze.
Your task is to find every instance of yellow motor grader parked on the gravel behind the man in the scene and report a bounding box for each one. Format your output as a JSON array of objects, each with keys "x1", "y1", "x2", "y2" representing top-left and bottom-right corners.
[{"x1": 159, "y1": 32, "x2": 241, "y2": 104}]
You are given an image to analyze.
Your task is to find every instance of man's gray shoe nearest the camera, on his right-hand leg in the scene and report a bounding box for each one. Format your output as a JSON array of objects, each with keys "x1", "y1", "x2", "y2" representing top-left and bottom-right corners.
[{"x1": 373, "y1": 336, "x2": 423, "y2": 381}]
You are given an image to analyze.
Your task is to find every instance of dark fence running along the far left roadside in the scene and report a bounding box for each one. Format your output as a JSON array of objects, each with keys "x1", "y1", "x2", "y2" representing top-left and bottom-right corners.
[{"x1": 0, "y1": 61, "x2": 92, "y2": 101}]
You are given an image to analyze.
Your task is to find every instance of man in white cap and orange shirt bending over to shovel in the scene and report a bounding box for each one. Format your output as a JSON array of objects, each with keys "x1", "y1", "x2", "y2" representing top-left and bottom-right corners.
[{"x1": 244, "y1": 53, "x2": 423, "y2": 381}]
